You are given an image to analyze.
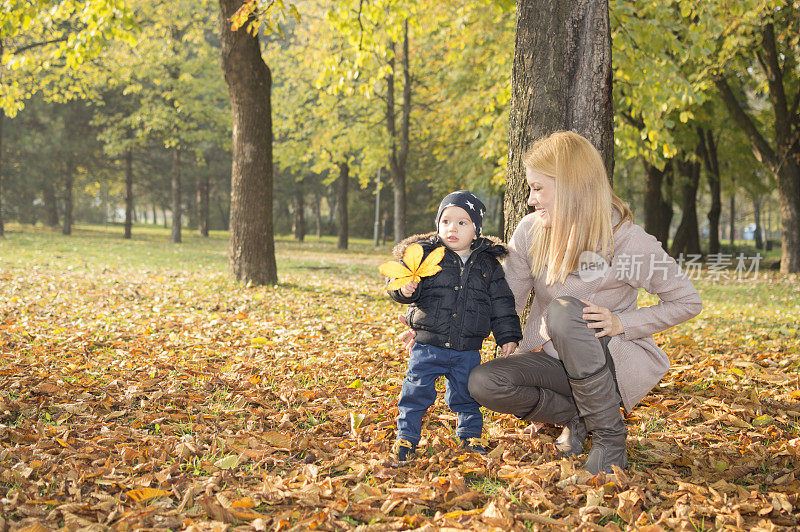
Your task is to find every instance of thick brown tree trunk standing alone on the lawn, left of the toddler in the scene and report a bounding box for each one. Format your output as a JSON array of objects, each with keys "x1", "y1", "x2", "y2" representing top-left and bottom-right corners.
[{"x1": 219, "y1": 0, "x2": 278, "y2": 285}]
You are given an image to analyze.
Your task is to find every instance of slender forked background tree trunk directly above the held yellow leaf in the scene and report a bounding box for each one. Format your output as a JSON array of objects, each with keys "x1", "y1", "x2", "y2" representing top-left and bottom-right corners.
[{"x1": 386, "y1": 20, "x2": 411, "y2": 242}]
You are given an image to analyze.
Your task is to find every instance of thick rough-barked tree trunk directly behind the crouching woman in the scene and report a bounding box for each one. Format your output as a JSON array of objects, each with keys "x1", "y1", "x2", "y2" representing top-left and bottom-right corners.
[{"x1": 504, "y1": 0, "x2": 614, "y2": 240}]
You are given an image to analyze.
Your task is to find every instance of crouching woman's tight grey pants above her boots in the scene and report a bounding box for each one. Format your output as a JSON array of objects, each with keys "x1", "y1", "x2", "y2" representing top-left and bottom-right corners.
[{"x1": 469, "y1": 297, "x2": 613, "y2": 418}]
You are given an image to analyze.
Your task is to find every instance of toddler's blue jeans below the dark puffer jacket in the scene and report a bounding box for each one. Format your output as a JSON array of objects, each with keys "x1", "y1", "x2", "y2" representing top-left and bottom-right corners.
[{"x1": 397, "y1": 342, "x2": 483, "y2": 445}]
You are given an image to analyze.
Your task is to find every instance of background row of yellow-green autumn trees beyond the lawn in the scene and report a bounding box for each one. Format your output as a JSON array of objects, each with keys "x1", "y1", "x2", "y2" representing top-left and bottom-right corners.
[{"x1": 0, "y1": 0, "x2": 800, "y2": 272}]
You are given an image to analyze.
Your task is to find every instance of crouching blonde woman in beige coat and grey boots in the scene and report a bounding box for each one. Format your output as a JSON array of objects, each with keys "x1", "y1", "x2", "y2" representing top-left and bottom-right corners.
[{"x1": 401, "y1": 131, "x2": 702, "y2": 474}]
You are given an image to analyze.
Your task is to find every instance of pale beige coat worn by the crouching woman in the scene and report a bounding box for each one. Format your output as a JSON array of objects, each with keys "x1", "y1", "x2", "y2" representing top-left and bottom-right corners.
[{"x1": 503, "y1": 212, "x2": 703, "y2": 411}]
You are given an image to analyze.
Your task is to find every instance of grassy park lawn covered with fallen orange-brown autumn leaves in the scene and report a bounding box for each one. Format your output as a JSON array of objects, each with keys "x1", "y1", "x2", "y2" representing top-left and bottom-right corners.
[{"x1": 0, "y1": 225, "x2": 800, "y2": 530}]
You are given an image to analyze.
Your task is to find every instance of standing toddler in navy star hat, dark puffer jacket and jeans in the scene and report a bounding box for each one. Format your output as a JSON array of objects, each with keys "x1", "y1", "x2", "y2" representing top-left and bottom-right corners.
[{"x1": 389, "y1": 190, "x2": 522, "y2": 462}]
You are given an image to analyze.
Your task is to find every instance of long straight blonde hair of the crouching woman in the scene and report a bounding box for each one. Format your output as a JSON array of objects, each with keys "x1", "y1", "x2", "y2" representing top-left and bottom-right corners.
[{"x1": 522, "y1": 131, "x2": 633, "y2": 285}]
